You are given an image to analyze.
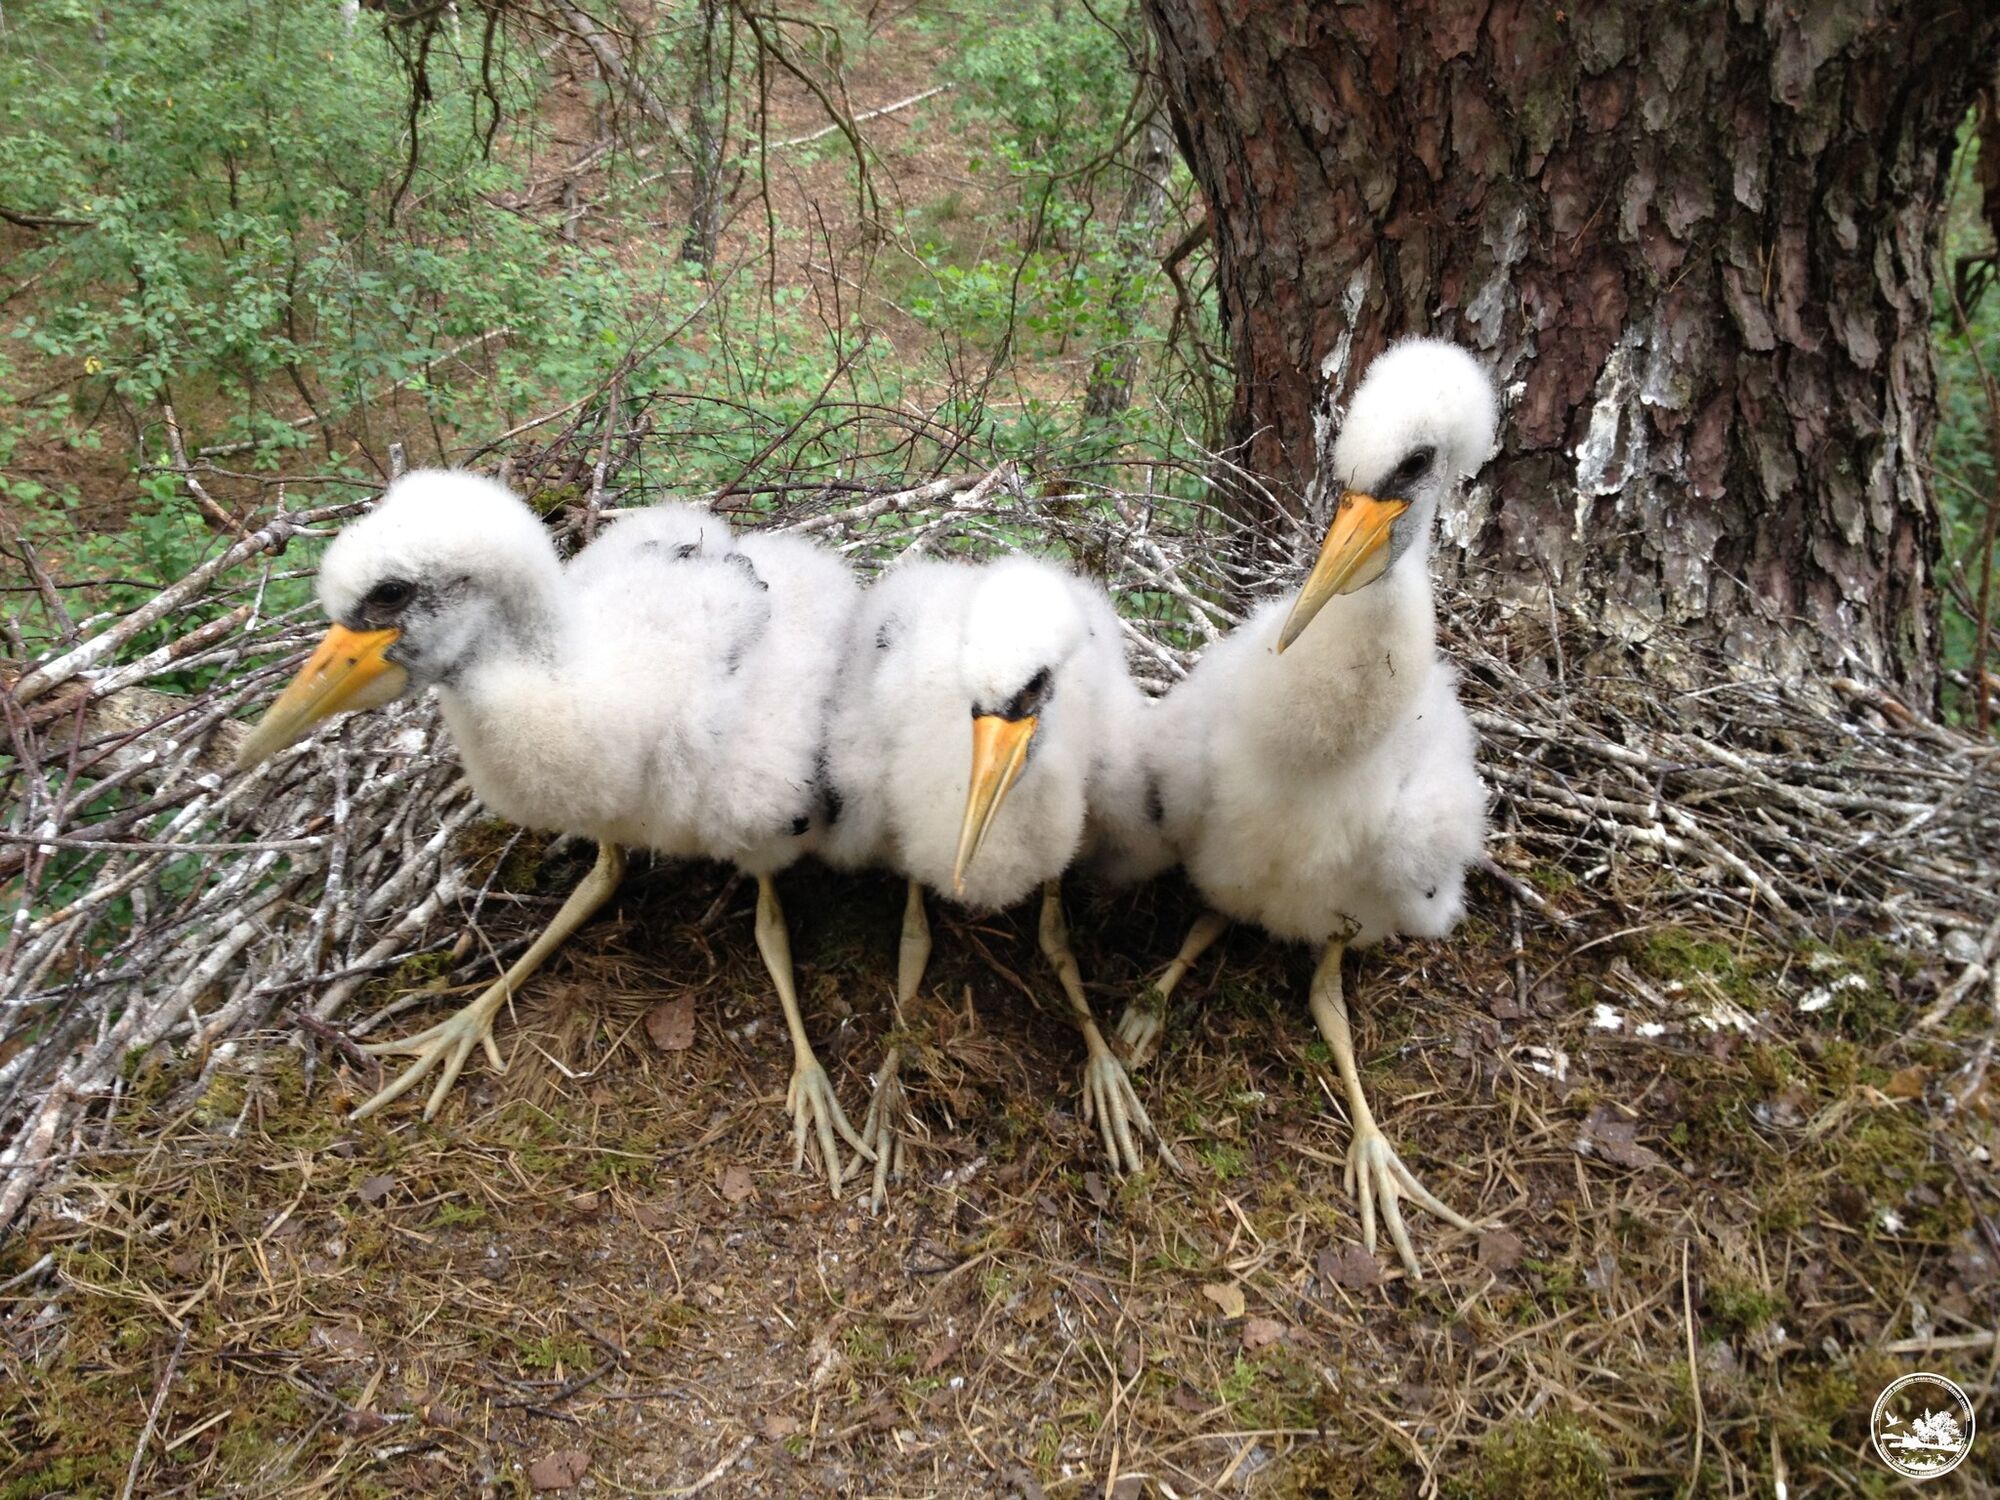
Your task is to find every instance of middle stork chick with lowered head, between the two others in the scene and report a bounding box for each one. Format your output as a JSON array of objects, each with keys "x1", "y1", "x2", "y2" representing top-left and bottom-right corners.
[{"x1": 822, "y1": 556, "x2": 1170, "y2": 1206}]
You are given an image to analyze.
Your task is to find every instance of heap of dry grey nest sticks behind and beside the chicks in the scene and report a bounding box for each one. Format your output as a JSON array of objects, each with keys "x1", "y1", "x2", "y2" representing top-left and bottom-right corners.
[{"x1": 0, "y1": 420, "x2": 2000, "y2": 1226}]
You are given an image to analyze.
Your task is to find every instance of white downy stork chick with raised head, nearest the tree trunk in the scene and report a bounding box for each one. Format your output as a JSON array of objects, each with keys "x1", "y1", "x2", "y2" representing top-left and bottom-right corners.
[{"x1": 1118, "y1": 340, "x2": 1498, "y2": 1278}]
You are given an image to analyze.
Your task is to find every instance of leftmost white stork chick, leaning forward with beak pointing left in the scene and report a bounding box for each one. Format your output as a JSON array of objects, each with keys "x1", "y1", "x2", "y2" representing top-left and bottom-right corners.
[{"x1": 240, "y1": 470, "x2": 864, "y2": 1196}]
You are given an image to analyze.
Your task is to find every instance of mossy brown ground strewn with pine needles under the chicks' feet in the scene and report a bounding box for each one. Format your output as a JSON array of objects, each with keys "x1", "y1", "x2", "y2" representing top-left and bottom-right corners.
[{"x1": 0, "y1": 850, "x2": 2000, "y2": 1500}]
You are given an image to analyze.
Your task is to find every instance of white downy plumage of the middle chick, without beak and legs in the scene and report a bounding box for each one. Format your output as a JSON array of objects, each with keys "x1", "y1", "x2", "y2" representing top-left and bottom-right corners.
[{"x1": 822, "y1": 556, "x2": 1172, "y2": 910}]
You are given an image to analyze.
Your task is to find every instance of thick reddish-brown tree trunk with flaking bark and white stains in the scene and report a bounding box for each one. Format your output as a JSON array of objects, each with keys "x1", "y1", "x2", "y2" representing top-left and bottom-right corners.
[{"x1": 1144, "y1": 0, "x2": 2000, "y2": 704}]
